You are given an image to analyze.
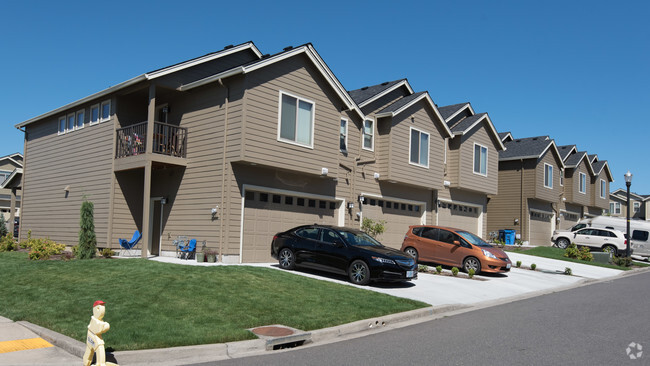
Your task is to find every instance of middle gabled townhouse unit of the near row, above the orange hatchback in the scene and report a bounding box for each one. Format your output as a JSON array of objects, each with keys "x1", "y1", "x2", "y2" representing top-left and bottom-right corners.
[{"x1": 342, "y1": 79, "x2": 452, "y2": 248}]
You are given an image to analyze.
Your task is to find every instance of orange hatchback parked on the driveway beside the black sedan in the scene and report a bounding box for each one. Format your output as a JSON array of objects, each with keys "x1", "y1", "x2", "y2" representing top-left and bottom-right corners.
[{"x1": 401, "y1": 225, "x2": 512, "y2": 274}]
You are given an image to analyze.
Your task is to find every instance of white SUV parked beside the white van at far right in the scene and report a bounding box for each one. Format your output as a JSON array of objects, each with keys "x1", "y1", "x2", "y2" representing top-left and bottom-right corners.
[{"x1": 551, "y1": 227, "x2": 632, "y2": 255}]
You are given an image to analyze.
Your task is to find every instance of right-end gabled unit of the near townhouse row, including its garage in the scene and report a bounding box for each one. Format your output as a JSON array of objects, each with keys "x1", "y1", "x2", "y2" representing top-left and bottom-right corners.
[{"x1": 438, "y1": 103, "x2": 505, "y2": 237}]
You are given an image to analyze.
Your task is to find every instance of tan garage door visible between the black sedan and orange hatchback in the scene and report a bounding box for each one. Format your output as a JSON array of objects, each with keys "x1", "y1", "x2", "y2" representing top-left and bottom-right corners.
[{"x1": 363, "y1": 197, "x2": 424, "y2": 249}]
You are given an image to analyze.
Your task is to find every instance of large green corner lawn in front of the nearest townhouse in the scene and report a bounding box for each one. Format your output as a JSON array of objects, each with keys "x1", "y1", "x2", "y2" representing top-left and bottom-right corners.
[{"x1": 0, "y1": 252, "x2": 428, "y2": 351}]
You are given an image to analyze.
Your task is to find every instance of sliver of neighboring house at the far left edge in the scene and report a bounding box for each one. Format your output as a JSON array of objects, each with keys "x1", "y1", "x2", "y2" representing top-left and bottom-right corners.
[{"x1": 0, "y1": 153, "x2": 23, "y2": 232}]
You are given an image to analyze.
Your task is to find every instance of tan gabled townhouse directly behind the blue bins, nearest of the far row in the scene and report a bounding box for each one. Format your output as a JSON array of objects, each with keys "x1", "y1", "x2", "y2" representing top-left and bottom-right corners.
[{"x1": 487, "y1": 134, "x2": 564, "y2": 245}]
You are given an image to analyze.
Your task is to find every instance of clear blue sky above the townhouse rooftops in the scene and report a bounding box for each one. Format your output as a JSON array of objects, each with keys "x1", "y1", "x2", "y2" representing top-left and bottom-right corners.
[{"x1": 0, "y1": 0, "x2": 650, "y2": 194}]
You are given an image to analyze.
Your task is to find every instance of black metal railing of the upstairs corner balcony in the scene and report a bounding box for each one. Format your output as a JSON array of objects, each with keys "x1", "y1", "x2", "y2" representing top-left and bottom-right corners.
[{"x1": 115, "y1": 122, "x2": 187, "y2": 158}]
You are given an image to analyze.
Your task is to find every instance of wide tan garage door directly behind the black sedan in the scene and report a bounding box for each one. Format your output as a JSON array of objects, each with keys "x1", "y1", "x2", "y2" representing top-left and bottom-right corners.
[{"x1": 242, "y1": 190, "x2": 340, "y2": 263}]
